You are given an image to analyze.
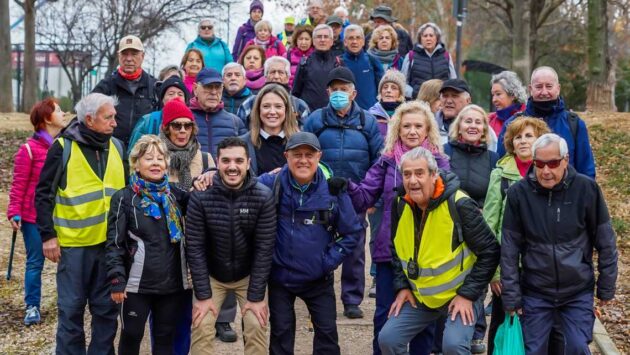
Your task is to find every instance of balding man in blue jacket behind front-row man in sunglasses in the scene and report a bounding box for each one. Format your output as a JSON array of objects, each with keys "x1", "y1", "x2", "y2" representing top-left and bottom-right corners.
[{"x1": 497, "y1": 67, "x2": 595, "y2": 179}]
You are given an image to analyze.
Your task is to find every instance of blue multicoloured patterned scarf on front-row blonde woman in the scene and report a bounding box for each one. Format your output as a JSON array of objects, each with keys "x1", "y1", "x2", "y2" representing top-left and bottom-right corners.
[{"x1": 130, "y1": 173, "x2": 183, "y2": 243}]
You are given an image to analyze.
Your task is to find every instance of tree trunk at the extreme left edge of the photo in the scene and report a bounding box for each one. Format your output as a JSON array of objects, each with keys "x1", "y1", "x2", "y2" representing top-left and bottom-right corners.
[{"x1": 0, "y1": 0, "x2": 13, "y2": 112}]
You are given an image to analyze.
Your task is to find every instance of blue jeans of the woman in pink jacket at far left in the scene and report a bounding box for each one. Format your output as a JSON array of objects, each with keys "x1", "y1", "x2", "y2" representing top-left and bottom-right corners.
[{"x1": 22, "y1": 222, "x2": 44, "y2": 308}]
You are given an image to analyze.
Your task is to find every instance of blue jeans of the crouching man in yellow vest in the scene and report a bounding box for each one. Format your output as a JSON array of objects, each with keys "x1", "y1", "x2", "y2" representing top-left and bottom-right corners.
[{"x1": 378, "y1": 300, "x2": 483, "y2": 355}]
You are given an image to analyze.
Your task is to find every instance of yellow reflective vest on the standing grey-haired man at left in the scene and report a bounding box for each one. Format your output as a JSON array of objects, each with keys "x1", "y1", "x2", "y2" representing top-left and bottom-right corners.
[{"x1": 53, "y1": 139, "x2": 125, "y2": 247}]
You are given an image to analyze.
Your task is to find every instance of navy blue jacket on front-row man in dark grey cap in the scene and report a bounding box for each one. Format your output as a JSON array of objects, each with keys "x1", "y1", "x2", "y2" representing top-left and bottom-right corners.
[{"x1": 258, "y1": 165, "x2": 363, "y2": 288}]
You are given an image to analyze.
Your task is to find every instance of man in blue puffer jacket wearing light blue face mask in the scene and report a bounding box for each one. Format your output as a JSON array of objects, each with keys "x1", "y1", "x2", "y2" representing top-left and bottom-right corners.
[{"x1": 304, "y1": 67, "x2": 383, "y2": 318}]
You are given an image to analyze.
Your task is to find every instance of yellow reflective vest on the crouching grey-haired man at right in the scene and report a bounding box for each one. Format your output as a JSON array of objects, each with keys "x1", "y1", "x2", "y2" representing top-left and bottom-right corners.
[{"x1": 394, "y1": 191, "x2": 477, "y2": 308}]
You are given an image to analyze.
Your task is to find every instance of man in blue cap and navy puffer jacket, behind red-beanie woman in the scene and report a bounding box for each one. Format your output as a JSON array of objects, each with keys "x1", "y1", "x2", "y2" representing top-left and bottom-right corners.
[{"x1": 190, "y1": 68, "x2": 247, "y2": 157}]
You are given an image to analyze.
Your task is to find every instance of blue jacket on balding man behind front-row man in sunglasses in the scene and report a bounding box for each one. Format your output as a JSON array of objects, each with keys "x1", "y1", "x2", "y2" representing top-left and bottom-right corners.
[{"x1": 497, "y1": 97, "x2": 595, "y2": 179}]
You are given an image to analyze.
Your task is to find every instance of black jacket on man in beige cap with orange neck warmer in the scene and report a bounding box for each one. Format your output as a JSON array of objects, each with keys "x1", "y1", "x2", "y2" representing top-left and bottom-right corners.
[{"x1": 92, "y1": 71, "x2": 158, "y2": 147}]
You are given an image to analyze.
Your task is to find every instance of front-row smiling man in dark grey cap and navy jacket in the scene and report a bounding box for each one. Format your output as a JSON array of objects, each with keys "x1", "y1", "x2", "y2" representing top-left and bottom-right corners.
[{"x1": 258, "y1": 132, "x2": 364, "y2": 355}]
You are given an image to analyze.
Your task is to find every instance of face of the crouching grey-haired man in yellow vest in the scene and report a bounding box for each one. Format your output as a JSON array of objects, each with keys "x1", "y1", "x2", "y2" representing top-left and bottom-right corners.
[{"x1": 401, "y1": 158, "x2": 438, "y2": 209}]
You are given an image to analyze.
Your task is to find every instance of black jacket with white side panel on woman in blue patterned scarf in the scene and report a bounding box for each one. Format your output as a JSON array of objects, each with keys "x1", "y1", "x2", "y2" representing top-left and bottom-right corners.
[{"x1": 105, "y1": 184, "x2": 190, "y2": 295}]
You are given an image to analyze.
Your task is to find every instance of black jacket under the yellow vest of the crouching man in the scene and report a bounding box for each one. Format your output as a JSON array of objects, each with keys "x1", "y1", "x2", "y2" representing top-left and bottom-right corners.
[{"x1": 392, "y1": 171, "x2": 500, "y2": 301}]
